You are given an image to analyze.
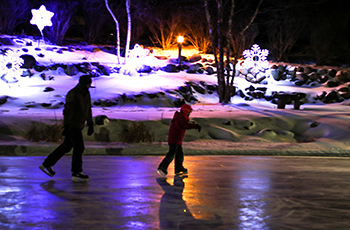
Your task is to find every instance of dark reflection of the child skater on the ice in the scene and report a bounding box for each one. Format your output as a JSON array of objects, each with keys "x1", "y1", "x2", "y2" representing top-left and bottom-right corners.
[{"x1": 157, "y1": 176, "x2": 222, "y2": 229}]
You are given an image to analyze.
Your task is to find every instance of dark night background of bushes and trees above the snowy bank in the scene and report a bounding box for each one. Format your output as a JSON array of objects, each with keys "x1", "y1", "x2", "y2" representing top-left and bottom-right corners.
[{"x1": 0, "y1": 0, "x2": 350, "y2": 65}]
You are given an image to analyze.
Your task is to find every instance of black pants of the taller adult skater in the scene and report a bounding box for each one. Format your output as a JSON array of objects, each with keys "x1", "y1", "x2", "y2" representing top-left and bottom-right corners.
[{"x1": 43, "y1": 128, "x2": 85, "y2": 173}]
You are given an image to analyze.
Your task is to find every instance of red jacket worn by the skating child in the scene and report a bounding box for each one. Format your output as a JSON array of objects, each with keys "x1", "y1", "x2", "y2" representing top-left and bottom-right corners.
[{"x1": 168, "y1": 111, "x2": 198, "y2": 145}]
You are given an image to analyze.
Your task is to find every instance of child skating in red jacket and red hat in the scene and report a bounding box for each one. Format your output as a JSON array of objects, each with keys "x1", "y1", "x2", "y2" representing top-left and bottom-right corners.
[{"x1": 157, "y1": 104, "x2": 201, "y2": 177}]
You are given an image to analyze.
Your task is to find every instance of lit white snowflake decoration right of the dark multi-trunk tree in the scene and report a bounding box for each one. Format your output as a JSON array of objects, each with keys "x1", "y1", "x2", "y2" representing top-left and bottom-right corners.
[{"x1": 243, "y1": 44, "x2": 269, "y2": 71}]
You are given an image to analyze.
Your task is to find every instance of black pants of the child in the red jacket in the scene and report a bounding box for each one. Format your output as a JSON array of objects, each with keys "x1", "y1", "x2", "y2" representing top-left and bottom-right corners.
[{"x1": 158, "y1": 144, "x2": 184, "y2": 173}]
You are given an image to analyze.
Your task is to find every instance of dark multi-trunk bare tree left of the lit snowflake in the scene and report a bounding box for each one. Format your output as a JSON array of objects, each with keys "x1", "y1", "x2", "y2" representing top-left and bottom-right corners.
[{"x1": 204, "y1": 0, "x2": 263, "y2": 103}]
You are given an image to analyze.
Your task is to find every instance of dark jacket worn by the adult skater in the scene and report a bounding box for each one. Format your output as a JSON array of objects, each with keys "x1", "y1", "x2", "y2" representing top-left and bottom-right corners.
[{"x1": 63, "y1": 84, "x2": 92, "y2": 129}]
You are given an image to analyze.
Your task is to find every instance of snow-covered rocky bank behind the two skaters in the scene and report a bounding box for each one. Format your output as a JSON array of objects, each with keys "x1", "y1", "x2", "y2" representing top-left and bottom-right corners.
[{"x1": 0, "y1": 37, "x2": 350, "y2": 155}]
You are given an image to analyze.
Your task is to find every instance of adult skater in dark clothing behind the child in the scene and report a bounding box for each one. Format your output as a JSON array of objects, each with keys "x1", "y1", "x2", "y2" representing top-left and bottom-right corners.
[{"x1": 39, "y1": 75, "x2": 94, "y2": 181}]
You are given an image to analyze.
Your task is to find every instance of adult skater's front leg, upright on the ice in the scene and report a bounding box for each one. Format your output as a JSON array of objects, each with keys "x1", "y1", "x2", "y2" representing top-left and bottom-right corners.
[{"x1": 71, "y1": 129, "x2": 85, "y2": 173}]
